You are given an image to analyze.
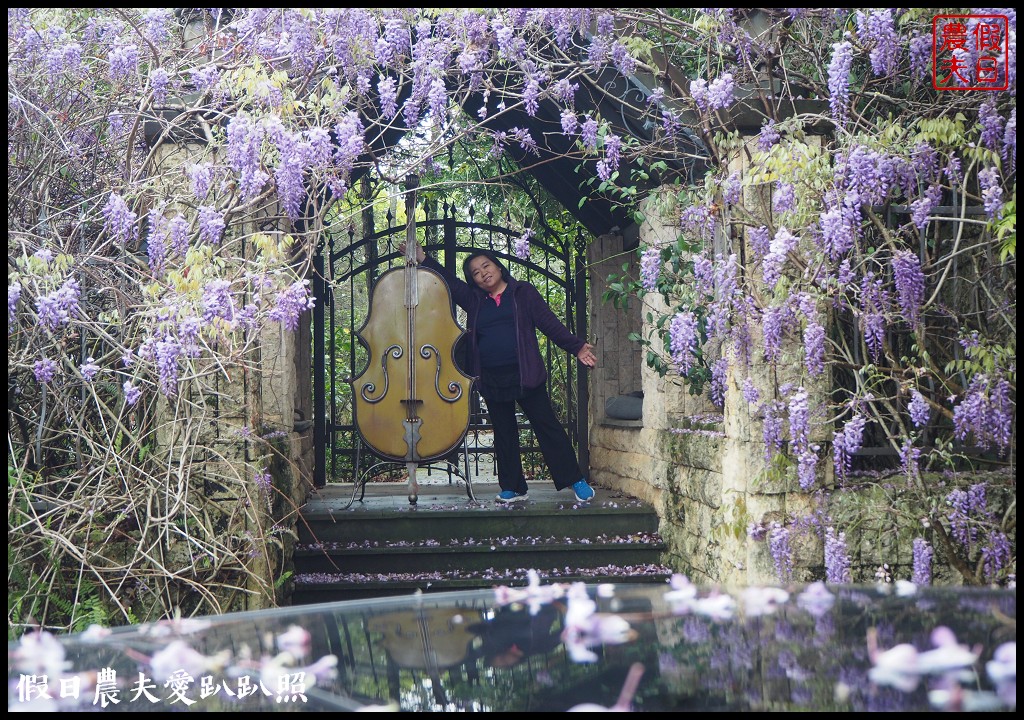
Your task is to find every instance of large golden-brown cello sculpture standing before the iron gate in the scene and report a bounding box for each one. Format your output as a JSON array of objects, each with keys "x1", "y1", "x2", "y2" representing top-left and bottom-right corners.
[{"x1": 351, "y1": 177, "x2": 473, "y2": 505}]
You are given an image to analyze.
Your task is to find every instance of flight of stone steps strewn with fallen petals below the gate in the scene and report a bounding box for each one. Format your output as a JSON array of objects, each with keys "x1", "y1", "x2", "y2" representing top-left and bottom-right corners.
[{"x1": 292, "y1": 483, "x2": 671, "y2": 604}]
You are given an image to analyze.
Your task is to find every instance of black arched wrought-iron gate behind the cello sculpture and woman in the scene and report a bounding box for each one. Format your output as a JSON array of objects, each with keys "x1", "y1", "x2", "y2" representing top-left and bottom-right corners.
[{"x1": 312, "y1": 199, "x2": 589, "y2": 488}]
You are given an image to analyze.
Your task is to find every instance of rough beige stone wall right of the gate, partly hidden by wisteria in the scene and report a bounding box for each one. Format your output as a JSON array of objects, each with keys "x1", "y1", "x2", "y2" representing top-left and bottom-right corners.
[{"x1": 590, "y1": 157, "x2": 831, "y2": 585}]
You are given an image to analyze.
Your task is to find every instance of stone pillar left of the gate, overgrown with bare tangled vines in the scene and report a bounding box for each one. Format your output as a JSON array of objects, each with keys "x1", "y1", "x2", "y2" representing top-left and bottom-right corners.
[{"x1": 142, "y1": 132, "x2": 312, "y2": 611}]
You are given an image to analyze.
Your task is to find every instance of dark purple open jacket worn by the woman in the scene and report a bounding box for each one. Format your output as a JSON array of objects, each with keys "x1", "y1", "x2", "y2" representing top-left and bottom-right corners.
[{"x1": 422, "y1": 257, "x2": 587, "y2": 388}]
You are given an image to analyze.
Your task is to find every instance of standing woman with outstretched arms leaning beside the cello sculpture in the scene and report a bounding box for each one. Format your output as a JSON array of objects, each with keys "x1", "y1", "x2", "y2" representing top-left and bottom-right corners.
[{"x1": 400, "y1": 243, "x2": 597, "y2": 503}]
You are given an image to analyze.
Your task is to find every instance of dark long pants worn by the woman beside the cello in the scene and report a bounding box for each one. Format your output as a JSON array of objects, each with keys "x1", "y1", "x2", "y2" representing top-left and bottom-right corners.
[{"x1": 487, "y1": 385, "x2": 583, "y2": 493}]
